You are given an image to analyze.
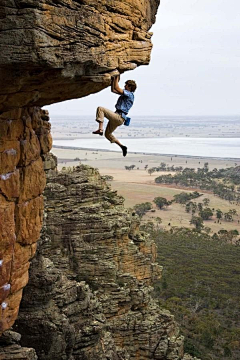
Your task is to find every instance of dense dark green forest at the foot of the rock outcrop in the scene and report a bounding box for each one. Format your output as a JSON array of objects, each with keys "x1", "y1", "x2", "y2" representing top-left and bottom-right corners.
[{"x1": 145, "y1": 223, "x2": 240, "y2": 360}]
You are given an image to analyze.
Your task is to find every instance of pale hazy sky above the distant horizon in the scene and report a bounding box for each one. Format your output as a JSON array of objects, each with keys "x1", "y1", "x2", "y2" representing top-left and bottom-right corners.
[{"x1": 45, "y1": 0, "x2": 240, "y2": 118}]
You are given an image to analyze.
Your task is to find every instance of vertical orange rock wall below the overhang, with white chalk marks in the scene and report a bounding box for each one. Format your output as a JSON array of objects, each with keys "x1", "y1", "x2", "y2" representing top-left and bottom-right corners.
[{"x1": 0, "y1": 107, "x2": 52, "y2": 334}]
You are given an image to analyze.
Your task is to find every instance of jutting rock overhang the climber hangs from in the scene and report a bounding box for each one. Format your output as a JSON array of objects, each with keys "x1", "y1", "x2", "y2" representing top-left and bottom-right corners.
[{"x1": 0, "y1": 0, "x2": 160, "y2": 112}]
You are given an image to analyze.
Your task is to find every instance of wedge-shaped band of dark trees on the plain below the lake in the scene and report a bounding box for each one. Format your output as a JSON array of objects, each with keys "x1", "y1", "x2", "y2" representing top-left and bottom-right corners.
[{"x1": 154, "y1": 163, "x2": 240, "y2": 203}]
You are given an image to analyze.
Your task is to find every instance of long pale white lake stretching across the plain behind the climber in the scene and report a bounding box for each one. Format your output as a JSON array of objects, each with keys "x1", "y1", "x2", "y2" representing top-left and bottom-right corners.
[{"x1": 53, "y1": 135, "x2": 240, "y2": 159}]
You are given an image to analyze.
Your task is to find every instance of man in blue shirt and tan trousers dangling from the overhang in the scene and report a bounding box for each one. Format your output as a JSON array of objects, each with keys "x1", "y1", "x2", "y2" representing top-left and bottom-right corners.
[{"x1": 93, "y1": 70, "x2": 137, "y2": 156}]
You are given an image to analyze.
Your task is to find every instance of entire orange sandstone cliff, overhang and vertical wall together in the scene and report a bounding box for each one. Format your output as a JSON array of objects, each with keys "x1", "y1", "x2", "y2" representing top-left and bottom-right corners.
[{"x1": 0, "y1": 0, "x2": 159, "y2": 334}]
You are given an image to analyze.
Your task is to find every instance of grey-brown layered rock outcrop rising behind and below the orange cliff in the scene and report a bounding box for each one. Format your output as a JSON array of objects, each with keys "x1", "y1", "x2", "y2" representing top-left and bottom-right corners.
[{"x1": 16, "y1": 166, "x2": 183, "y2": 360}]
